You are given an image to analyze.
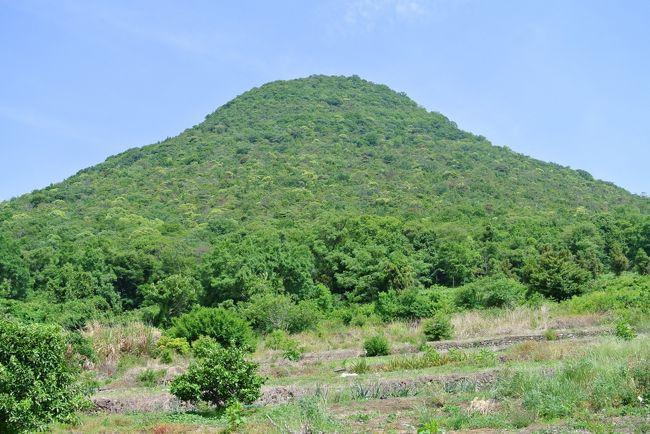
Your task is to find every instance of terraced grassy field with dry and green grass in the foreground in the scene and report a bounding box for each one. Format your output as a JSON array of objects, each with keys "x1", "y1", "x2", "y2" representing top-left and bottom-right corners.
[{"x1": 53, "y1": 307, "x2": 650, "y2": 434}]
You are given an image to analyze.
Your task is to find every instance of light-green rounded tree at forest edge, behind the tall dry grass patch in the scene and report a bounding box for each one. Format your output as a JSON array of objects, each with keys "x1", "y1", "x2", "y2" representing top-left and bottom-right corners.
[{"x1": 142, "y1": 274, "x2": 201, "y2": 326}]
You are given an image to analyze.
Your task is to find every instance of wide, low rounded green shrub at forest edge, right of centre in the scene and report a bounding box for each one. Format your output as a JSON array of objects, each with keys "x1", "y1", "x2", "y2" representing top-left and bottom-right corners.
[{"x1": 455, "y1": 277, "x2": 526, "y2": 309}]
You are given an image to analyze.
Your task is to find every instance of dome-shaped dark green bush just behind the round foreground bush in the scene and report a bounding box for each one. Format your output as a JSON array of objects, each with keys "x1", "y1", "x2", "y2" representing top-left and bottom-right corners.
[{"x1": 168, "y1": 307, "x2": 255, "y2": 351}]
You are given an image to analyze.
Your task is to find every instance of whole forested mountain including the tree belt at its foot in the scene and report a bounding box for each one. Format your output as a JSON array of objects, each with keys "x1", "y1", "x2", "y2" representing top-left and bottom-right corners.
[{"x1": 0, "y1": 76, "x2": 650, "y2": 322}]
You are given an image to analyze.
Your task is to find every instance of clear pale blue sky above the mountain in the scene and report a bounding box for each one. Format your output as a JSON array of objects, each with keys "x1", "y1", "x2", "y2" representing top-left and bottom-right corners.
[{"x1": 0, "y1": 0, "x2": 650, "y2": 200}]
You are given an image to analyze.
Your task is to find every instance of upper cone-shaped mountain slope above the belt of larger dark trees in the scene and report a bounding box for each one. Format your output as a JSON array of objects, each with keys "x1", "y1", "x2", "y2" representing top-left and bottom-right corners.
[{"x1": 3, "y1": 76, "x2": 647, "y2": 227}]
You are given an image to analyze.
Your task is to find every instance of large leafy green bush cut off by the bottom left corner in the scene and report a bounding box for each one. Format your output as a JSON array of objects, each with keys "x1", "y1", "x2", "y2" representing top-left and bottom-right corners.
[{"x1": 0, "y1": 320, "x2": 88, "y2": 433}]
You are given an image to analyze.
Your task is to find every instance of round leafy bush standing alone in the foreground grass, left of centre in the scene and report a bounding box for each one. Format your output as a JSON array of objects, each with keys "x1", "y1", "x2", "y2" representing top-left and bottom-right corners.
[{"x1": 170, "y1": 345, "x2": 264, "y2": 408}]
